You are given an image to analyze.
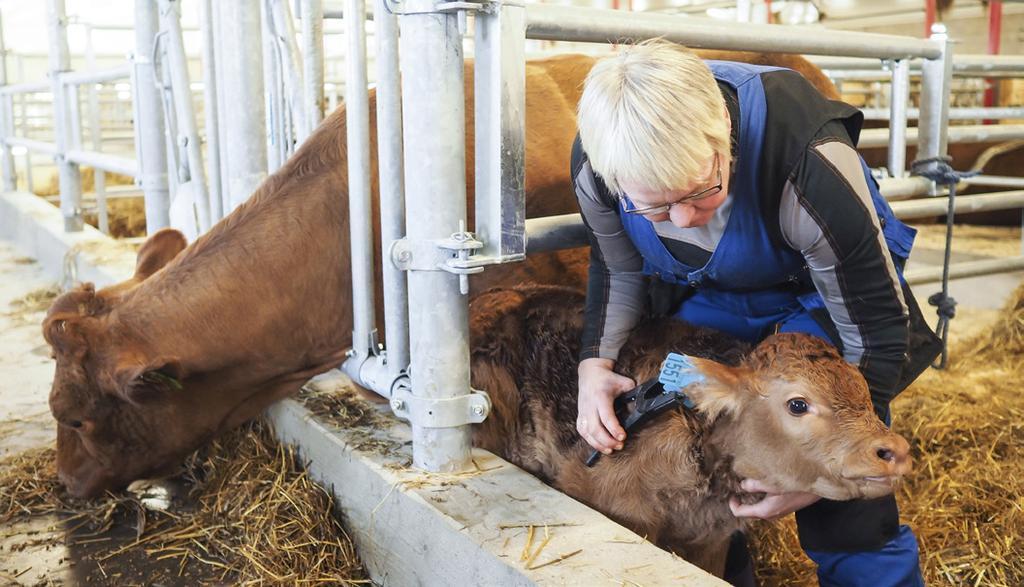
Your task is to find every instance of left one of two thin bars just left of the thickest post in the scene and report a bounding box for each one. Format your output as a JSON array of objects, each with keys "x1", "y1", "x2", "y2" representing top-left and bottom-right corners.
[{"x1": 345, "y1": 0, "x2": 377, "y2": 357}]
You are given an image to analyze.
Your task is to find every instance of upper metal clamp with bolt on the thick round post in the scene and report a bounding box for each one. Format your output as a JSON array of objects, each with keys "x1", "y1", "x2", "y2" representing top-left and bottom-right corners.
[{"x1": 390, "y1": 222, "x2": 490, "y2": 295}]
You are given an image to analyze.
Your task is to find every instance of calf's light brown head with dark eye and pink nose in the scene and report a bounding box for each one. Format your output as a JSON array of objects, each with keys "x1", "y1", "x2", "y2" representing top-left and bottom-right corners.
[{"x1": 692, "y1": 334, "x2": 910, "y2": 500}]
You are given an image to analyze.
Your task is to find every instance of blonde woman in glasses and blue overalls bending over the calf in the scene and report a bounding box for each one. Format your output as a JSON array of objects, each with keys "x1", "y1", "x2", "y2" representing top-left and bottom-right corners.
[{"x1": 571, "y1": 41, "x2": 937, "y2": 587}]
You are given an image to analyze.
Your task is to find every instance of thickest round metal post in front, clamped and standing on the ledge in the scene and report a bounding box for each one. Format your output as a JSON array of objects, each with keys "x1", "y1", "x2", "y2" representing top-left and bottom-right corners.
[{"x1": 401, "y1": 0, "x2": 470, "y2": 471}]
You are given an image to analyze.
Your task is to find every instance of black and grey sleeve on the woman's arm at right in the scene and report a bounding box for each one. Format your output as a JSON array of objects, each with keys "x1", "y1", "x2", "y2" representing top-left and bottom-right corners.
[{"x1": 779, "y1": 138, "x2": 908, "y2": 405}]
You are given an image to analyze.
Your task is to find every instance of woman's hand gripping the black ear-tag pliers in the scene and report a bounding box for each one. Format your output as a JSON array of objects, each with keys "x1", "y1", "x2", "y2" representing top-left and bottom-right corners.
[{"x1": 577, "y1": 359, "x2": 636, "y2": 455}]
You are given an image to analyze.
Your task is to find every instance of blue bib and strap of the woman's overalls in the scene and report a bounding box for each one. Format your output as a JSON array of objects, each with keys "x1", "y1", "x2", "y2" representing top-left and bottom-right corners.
[{"x1": 620, "y1": 61, "x2": 916, "y2": 343}]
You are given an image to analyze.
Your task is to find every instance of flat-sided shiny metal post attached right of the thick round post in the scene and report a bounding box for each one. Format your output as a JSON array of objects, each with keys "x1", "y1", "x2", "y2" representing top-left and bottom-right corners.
[{"x1": 473, "y1": 4, "x2": 526, "y2": 260}]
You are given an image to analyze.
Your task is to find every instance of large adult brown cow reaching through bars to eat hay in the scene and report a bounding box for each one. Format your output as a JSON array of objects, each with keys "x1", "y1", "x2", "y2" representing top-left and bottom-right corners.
[{"x1": 43, "y1": 55, "x2": 835, "y2": 496}]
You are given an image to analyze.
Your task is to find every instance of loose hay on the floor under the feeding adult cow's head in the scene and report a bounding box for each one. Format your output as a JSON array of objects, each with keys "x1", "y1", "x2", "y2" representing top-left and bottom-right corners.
[{"x1": 0, "y1": 422, "x2": 368, "y2": 585}]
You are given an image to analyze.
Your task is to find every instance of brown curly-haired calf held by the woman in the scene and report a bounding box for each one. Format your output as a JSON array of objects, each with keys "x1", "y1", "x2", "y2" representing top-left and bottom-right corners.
[{"x1": 471, "y1": 286, "x2": 910, "y2": 576}]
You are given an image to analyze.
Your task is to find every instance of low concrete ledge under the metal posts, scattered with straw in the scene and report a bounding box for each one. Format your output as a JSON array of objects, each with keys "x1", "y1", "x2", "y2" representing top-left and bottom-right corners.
[{"x1": 0, "y1": 189, "x2": 726, "y2": 587}]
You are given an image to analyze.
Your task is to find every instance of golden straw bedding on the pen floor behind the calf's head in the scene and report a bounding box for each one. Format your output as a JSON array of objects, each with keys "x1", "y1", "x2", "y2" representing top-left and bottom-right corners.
[{"x1": 755, "y1": 286, "x2": 1024, "y2": 587}]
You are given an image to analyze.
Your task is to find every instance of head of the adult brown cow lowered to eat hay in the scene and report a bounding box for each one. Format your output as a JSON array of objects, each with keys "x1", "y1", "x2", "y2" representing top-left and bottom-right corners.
[{"x1": 43, "y1": 230, "x2": 237, "y2": 497}]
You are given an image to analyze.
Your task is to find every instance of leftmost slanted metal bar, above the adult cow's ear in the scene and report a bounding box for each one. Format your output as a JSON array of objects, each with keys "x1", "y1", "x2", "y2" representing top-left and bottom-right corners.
[{"x1": 159, "y1": 0, "x2": 211, "y2": 233}]
